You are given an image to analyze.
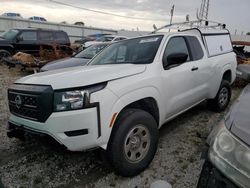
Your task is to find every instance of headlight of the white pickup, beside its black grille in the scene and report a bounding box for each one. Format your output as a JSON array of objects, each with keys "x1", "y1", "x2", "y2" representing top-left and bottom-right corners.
[{"x1": 54, "y1": 83, "x2": 106, "y2": 112}]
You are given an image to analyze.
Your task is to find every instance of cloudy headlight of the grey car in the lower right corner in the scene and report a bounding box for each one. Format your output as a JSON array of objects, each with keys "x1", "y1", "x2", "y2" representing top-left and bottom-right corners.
[{"x1": 209, "y1": 121, "x2": 250, "y2": 187}]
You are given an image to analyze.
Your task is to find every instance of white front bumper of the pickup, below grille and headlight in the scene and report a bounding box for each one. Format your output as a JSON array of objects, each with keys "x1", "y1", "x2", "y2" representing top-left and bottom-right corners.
[{"x1": 8, "y1": 107, "x2": 100, "y2": 151}]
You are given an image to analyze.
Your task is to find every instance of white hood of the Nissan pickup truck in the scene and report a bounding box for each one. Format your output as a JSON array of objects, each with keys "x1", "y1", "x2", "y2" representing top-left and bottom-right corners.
[{"x1": 15, "y1": 64, "x2": 146, "y2": 89}]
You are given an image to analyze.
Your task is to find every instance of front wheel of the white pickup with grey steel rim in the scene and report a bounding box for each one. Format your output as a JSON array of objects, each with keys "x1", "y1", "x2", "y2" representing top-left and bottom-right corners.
[{"x1": 107, "y1": 109, "x2": 159, "y2": 177}]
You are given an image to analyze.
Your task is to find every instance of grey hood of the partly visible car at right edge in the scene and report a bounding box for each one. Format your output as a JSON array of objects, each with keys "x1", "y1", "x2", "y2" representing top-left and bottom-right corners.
[{"x1": 226, "y1": 84, "x2": 250, "y2": 146}]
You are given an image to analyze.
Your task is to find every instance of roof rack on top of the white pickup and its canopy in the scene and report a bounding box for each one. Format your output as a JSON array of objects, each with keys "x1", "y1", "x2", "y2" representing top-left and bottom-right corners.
[{"x1": 151, "y1": 19, "x2": 226, "y2": 33}]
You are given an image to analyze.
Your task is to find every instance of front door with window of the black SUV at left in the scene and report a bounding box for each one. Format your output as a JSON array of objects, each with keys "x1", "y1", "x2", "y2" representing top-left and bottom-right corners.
[{"x1": 15, "y1": 30, "x2": 39, "y2": 54}]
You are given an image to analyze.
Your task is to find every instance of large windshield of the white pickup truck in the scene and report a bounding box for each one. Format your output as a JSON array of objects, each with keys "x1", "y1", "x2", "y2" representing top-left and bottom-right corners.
[{"x1": 89, "y1": 35, "x2": 163, "y2": 65}]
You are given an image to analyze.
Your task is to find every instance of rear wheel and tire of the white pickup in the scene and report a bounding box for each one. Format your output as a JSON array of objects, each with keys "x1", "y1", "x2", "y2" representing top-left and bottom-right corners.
[{"x1": 208, "y1": 80, "x2": 232, "y2": 112}]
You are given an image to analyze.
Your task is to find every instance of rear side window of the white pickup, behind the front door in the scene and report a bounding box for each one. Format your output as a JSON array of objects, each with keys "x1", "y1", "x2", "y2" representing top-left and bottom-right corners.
[{"x1": 186, "y1": 36, "x2": 204, "y2": 61}]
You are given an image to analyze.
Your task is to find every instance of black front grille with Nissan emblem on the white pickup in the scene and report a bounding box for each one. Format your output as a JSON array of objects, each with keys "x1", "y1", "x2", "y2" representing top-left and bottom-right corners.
[{"x1": 8, "y1": 84, "x2": 53, "y2": 122}]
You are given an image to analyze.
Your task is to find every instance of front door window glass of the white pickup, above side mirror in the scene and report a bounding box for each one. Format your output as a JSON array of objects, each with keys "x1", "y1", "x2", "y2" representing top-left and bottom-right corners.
[{"x1": 164, "y1": 37, "x2": 190, "y2": 64}]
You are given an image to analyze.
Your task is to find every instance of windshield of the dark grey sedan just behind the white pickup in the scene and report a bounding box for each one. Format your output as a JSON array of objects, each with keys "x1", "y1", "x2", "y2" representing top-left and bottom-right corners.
[{"x1": 74, "y1": 44, "x2": 108, "y2": 59}]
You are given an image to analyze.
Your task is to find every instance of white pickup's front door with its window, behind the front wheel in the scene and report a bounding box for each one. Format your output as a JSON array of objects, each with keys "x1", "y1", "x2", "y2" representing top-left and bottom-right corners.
[{"x1": 162, "y1": 36, "x2": 205, "y2": 119}]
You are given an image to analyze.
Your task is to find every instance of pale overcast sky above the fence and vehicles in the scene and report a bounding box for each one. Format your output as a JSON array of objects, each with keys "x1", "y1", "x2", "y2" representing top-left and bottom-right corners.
[{"x1": 0, "y1": 0, "x2": 250, "y2": 34}]
